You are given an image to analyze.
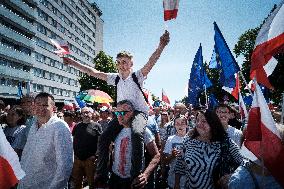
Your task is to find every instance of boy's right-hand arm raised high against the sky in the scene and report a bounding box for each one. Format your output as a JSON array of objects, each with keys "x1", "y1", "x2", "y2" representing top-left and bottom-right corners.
[{"x1": 141, "y1": 30, "x2": 170, "y2": 77}]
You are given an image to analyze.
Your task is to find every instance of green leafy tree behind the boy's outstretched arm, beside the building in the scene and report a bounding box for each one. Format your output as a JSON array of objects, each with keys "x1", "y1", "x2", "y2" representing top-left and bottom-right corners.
[{"x1": 79, "y1": 51, "x2": 117, "y2": 99}]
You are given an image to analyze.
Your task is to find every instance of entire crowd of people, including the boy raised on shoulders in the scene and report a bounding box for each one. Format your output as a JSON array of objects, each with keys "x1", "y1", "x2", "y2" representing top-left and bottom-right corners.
[{"x1": 0, "y1": 31, "x2": 283, "y2": 189}]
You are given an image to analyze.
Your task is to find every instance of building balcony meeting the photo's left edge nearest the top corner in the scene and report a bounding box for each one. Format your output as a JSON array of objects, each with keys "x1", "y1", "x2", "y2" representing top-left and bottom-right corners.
[{"x1": 0, "y1": 5, "x2": 36, "y2": 34}]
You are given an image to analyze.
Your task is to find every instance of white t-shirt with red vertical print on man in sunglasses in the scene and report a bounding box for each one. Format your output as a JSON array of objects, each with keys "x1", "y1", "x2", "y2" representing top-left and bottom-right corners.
[{"x1": 112, "y1": 128, "x2": 155, "y2": 178}]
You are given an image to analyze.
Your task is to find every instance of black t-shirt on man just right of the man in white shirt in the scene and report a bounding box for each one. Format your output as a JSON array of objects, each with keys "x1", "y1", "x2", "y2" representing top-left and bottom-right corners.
[{"x1": 72, "y1": 122, "x2": 102, "y2": 160}]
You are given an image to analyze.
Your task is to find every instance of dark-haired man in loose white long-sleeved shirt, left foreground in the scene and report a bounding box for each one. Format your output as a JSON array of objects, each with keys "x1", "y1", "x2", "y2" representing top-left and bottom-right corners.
[{"x1": 18, "y1": 93, "x2": 73, "y2": 189}]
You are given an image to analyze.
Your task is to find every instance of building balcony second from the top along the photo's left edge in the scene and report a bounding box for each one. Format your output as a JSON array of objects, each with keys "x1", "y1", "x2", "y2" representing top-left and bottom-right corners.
[{"x1": 0, "y1": 25, "x2": 35, "y2": 49}]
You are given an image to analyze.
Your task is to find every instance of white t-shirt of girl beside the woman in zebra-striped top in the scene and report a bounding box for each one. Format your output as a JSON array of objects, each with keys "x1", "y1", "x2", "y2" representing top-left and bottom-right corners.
[{"x1": 164, "y1": 135, "x2": 185, "y2": 188}]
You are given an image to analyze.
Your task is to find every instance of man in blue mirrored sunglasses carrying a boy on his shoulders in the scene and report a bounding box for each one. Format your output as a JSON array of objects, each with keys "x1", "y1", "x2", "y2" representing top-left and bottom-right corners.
[{"x1": 109, "y1": 100, "x2": 160, "y2": 189}]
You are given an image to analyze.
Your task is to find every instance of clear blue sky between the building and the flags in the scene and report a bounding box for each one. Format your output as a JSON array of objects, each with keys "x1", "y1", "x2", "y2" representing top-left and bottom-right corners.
[{"x1": 92, "y1": 0, "x2": 281, "y2": 104}]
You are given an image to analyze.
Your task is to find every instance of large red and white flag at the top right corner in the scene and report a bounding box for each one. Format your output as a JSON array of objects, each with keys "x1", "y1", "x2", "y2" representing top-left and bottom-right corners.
[{"x1": 250, "y1": 1, "x2": 284, "y2": 88}]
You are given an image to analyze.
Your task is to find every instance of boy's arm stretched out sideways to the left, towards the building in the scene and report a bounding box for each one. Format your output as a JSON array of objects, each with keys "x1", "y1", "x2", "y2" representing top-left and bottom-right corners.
[{"x1": 64, "y1": 57, "x2": 107, "y2": 81}]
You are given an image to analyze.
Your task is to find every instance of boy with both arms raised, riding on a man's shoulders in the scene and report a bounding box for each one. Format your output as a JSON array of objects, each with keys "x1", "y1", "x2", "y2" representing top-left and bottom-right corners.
[{"x1": 65, "y1": 31, "x2": 170, "y2": 185}]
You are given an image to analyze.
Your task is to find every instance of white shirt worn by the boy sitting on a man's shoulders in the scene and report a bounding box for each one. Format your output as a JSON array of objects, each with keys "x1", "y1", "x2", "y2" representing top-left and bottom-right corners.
[{"x1": 107, "y1": 70, "x2": 149, "y2": 115}]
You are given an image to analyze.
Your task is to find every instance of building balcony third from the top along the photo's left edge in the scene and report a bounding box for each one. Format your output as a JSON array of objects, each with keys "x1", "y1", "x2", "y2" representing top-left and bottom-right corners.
[{"x1": 0, "y1": 44, "x2": 35, "y2": 65}]
